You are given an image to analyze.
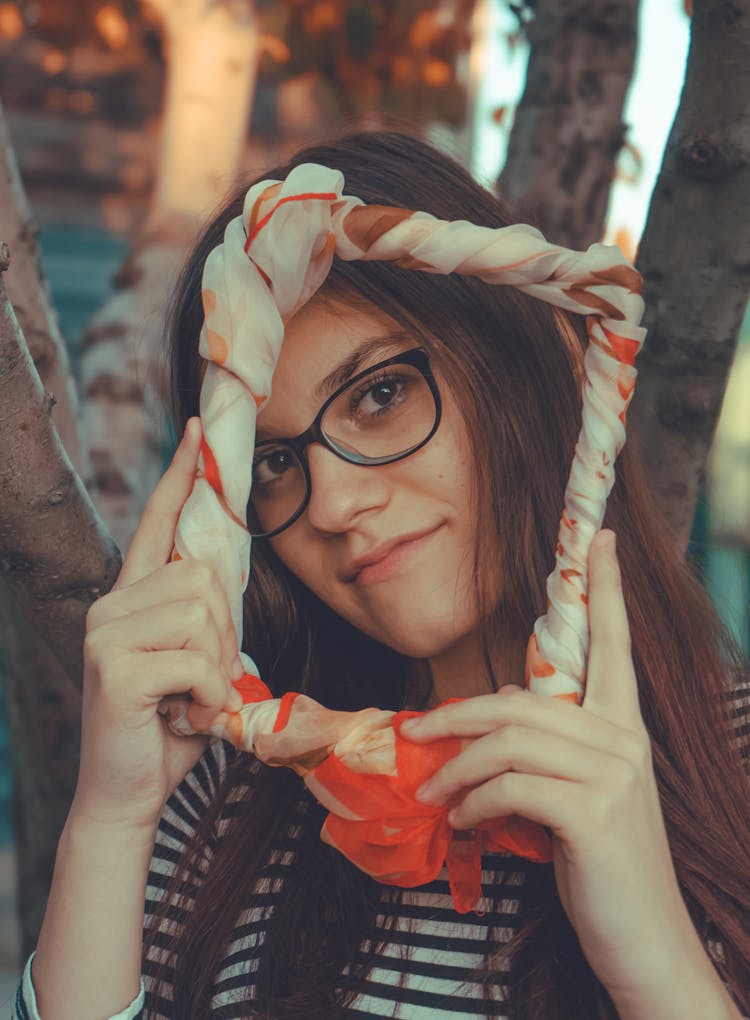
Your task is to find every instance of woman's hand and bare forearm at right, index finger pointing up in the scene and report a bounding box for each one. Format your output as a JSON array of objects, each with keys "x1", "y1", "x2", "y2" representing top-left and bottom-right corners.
[{"x1": 401, "y1": 531, "x2": 718, "y2": 1016}]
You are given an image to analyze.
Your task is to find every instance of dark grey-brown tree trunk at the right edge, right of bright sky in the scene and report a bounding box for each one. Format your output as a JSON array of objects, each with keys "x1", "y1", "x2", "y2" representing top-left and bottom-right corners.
[{"x1": 630, "y1": 0, "x2": 750, "y2": 550}]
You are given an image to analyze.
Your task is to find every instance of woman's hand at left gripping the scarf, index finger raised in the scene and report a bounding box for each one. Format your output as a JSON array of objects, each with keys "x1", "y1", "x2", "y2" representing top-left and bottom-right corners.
[{"x1": 71, "y1": 418, "x2": 243, "y2": 829}]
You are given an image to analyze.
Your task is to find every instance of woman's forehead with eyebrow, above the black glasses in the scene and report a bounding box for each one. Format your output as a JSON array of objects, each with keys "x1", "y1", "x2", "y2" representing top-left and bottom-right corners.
[{"x1": 257, "y1": 298, "x2": 414, "y2": 439}]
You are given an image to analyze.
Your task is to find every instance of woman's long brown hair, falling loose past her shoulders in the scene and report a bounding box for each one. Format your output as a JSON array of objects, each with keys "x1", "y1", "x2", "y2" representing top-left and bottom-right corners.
[{"x1": 149, "y1": 132, "x2": 750, "y2": 1020}]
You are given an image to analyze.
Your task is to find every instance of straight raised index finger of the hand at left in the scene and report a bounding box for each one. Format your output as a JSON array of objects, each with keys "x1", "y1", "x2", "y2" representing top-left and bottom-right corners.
[{"x1": 113, "y1": 417, "x2": 203, "y2": 590}]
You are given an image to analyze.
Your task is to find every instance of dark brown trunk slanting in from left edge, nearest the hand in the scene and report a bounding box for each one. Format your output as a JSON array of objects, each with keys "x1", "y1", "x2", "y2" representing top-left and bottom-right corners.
[{"x1": 0, "y1": 259, "x2": 120, "y2": 681}]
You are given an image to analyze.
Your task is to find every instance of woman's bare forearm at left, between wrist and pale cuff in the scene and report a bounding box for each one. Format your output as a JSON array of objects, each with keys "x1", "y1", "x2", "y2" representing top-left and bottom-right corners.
[{"x1": 32, "y1": 813, "x2": 155, "y2": 1020}]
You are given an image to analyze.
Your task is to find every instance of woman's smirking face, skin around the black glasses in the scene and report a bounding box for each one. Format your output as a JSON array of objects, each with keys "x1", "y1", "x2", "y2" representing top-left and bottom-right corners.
[{"x1": 258, "y1": 297, "x2": 477, "y2": 659}]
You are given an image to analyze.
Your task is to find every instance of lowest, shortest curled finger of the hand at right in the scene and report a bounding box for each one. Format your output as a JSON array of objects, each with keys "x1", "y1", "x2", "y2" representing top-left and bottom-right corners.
[{"x1": 448, "y1": 772, "x2": 584, "y2": 836}]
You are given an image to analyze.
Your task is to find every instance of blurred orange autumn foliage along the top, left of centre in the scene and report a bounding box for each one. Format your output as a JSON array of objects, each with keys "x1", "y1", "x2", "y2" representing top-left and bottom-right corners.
[{"x1": 0, "y1": 0, "x2": 474, "y2": 124}]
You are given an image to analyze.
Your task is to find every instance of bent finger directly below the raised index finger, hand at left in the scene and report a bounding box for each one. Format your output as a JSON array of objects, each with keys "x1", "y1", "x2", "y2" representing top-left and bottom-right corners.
[{"x1": 88, "y1": 560, "x2": 244, "y2": 679}]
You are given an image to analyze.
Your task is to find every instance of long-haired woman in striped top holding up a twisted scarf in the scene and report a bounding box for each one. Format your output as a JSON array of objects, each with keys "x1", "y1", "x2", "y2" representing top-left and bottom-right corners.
[{"x1": 13, "y1": 133, "x2": 750, "y2": 1020}]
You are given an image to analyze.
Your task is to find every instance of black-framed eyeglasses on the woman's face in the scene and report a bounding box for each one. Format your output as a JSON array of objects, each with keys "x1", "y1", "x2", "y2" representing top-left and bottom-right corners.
[{"x1": 247, "y1": 347, "x2": 442, "y2": 539}]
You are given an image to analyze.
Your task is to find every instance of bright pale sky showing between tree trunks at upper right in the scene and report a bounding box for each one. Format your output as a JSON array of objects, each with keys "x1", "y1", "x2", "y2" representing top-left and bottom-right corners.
[{"x1": 471, "y1": 0, "x2": 690, "y2": 242}]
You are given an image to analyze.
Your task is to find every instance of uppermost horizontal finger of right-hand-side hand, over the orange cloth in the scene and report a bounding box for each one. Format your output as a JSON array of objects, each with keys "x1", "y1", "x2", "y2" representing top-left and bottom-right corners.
[{"x1": 400, "y1": 691, "x2": 627, "y2": 753}]
